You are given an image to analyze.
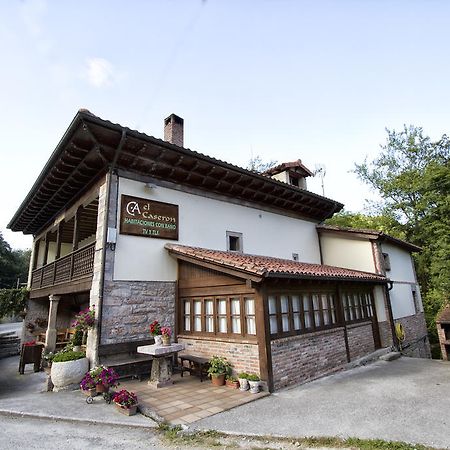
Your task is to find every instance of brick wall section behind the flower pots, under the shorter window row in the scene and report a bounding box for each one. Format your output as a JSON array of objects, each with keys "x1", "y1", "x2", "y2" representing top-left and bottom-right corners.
[{"x1": 178, "y1": 337, "x2": 260, "y2": 375}]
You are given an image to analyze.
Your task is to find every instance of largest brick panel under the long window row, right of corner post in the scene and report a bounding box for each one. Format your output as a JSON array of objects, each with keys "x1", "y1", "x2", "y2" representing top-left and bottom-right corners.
[{"x1": 271, "y1": 328, "x2": 347, "y2": 390}]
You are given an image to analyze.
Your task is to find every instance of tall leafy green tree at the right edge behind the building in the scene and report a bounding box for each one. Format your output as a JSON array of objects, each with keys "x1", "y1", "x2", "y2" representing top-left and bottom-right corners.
[{"x1": 354, "y1": 126, "x2": 450, "y2": 346}]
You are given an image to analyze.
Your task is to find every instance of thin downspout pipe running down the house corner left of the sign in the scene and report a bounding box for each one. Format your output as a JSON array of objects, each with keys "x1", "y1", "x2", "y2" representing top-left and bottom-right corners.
[{"x1": 95, "y1": 130, "x2": 127, "y2": 364}]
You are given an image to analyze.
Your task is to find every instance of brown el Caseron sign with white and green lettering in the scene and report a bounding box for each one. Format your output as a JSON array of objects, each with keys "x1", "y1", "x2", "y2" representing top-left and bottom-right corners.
[{"x1": 120, "y1": 195, "x2": 178, "y2": 240}]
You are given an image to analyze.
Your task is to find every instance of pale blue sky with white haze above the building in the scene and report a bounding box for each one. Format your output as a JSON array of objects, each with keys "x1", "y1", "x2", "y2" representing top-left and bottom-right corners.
[{"x1": 0, "y1": 0, "x2": 450, "y2": 248}]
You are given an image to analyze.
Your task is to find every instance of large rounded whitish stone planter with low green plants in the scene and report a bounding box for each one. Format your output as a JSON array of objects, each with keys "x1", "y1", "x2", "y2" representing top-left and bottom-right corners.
[{"x1": 50, "y1": 349, "x2": 89, "y2": 392}]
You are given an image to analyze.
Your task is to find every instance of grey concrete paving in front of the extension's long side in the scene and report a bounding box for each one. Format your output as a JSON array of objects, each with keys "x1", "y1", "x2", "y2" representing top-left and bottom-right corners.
[{"x1": 192, "y1": 357, "x2": 450, "y2": 448}]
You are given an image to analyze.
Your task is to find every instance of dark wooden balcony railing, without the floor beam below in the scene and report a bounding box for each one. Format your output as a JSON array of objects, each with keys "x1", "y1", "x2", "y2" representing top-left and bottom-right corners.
[{"x1": 31, "y1": 242, "x2": 95, "y2": 289}]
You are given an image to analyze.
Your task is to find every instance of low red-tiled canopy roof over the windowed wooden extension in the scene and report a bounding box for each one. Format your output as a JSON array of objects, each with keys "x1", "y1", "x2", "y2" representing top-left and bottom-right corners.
[{"x1": 165, "y1": 244, "x2": 387, "y2": 283}]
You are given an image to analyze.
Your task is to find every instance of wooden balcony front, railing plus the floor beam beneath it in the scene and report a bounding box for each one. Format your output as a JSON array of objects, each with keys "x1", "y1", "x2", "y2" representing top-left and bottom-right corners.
[{"x1": 30, "y1": 242, "x2": 95, "y2": 298}]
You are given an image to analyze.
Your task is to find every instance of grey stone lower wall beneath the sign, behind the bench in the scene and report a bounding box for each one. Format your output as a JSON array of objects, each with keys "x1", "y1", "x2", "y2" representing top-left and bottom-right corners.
[{"x1": 100, "y1": 281, "x2": 176, "y2": 344}]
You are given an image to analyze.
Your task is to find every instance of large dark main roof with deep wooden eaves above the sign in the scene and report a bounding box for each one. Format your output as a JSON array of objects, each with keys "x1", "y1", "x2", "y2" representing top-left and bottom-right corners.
[{"x1": 8, "y1": 109, "x2": 343, "y2": 234}]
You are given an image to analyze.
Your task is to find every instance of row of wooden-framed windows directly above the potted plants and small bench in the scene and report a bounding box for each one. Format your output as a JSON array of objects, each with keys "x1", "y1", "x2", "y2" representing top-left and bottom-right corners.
[{"x1": 180, "y1": 295, "x2": 256, "y2": 336}]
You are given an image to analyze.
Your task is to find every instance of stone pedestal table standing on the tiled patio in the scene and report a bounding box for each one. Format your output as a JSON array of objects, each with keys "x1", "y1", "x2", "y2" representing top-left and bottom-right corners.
[{"x1": 137, "y1": 344, "x2": 184, "y2": 388}]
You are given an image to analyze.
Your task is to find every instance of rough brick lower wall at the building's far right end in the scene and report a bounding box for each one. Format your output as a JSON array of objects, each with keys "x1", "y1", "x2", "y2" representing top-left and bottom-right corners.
[{"x1": 395, "y1": 312, "x2": 431, "y2": 358}]
